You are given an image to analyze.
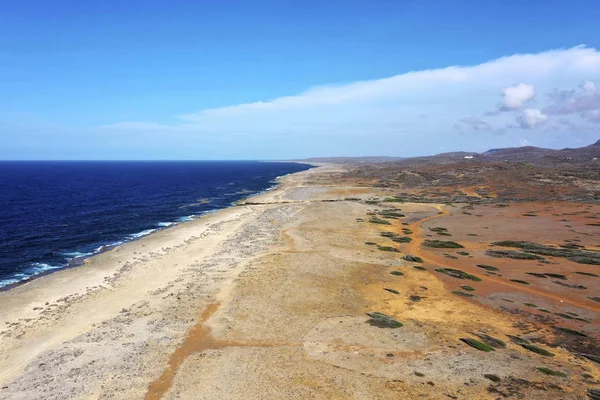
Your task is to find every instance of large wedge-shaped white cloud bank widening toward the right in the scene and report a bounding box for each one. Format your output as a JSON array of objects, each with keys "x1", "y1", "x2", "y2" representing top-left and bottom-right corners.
[{"x1": 94, "y1": 46, "x2": 600, "y2": 155}]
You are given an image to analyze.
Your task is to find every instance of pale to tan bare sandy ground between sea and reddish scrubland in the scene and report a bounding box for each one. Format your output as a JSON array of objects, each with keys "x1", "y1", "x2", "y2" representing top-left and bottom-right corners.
[{"x1": 0, "y1": 165, "x2": 598, "y2": 399}]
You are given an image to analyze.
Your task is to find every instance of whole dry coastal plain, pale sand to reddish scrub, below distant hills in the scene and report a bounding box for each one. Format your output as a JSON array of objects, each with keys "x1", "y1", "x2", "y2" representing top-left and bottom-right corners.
[{"x1": 0, "y1": 161, "x2": 600, "y2": 399}]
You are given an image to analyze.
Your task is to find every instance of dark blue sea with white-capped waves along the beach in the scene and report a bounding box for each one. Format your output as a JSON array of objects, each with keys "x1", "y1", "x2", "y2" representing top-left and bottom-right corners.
[{"x1": 0, "y1": 161, "x2": 310, "y2": 287}]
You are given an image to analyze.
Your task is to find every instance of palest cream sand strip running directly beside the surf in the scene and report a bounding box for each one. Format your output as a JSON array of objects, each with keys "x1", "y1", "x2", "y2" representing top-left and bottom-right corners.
[{"x1": 0, "y1": 164, "x2": 324, "y2": 398}]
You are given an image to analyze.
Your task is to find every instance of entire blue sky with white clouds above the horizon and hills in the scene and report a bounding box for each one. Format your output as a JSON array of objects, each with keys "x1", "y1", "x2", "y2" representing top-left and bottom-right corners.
[{"x1": 0, "y1": 0, "x2": 600, "y2": 159}]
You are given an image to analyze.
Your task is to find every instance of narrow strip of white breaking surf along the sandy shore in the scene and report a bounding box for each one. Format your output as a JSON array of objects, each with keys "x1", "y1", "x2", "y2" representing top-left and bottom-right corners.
[{"x1": 0, "y1": 161, "x2": 318, "y2": 293}]
